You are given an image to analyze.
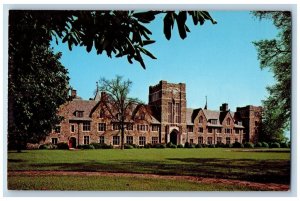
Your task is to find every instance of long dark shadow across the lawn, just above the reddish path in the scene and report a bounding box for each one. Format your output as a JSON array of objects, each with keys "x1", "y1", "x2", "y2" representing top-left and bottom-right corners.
[{"x1": 26, "y1": 158, "x2": 290, "y2": 184}]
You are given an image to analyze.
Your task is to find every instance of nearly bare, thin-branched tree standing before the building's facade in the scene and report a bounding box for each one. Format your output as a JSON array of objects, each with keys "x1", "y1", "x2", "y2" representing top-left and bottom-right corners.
[{"x1": 98, "y1": 76, "x2": 140, "y2": 149}]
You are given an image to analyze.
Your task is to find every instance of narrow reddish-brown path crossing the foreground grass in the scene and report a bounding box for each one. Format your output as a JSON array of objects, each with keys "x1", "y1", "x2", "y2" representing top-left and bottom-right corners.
[{"x1": 8, "y1": 171, "x2": 290, "y2": 191}]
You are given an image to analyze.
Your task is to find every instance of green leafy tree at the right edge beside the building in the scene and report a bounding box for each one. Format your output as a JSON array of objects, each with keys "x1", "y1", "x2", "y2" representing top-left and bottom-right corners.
[{"x1": 253, "y1": 11, "x2": 292, "y2": 141}]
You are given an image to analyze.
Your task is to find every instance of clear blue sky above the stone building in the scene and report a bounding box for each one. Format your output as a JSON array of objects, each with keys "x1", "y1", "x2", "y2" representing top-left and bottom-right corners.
[{"x1": 53, "y1": 11, "x2": 277, "y2": 111}]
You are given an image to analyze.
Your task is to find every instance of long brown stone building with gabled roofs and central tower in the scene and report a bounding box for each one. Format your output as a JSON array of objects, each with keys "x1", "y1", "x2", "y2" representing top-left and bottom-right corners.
[{"x1": 46, "y1": 81, "x2": 262, "y2": 148}]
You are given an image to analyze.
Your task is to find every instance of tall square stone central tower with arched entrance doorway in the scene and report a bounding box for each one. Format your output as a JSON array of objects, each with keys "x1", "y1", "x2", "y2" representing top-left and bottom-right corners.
[{"x1": 149, "y1": 80, "x2": 186, "y2": 144}]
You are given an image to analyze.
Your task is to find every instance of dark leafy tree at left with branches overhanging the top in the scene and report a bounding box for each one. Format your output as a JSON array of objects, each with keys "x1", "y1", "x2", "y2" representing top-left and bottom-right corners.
[{"x1": 8, "y1": 10, "x2": 216, "y2": 149}]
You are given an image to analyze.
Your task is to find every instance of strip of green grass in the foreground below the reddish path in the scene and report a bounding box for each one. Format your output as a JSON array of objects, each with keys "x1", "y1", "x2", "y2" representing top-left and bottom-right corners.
[{"x1": 8, "y1": 176, "x2": 261, "y2": 191}]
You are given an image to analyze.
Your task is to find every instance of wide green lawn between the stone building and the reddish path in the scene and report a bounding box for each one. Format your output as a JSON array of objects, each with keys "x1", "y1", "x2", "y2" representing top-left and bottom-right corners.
[{"x1": 8, "y1": 148, "x2": 290, "y2": 190}]
